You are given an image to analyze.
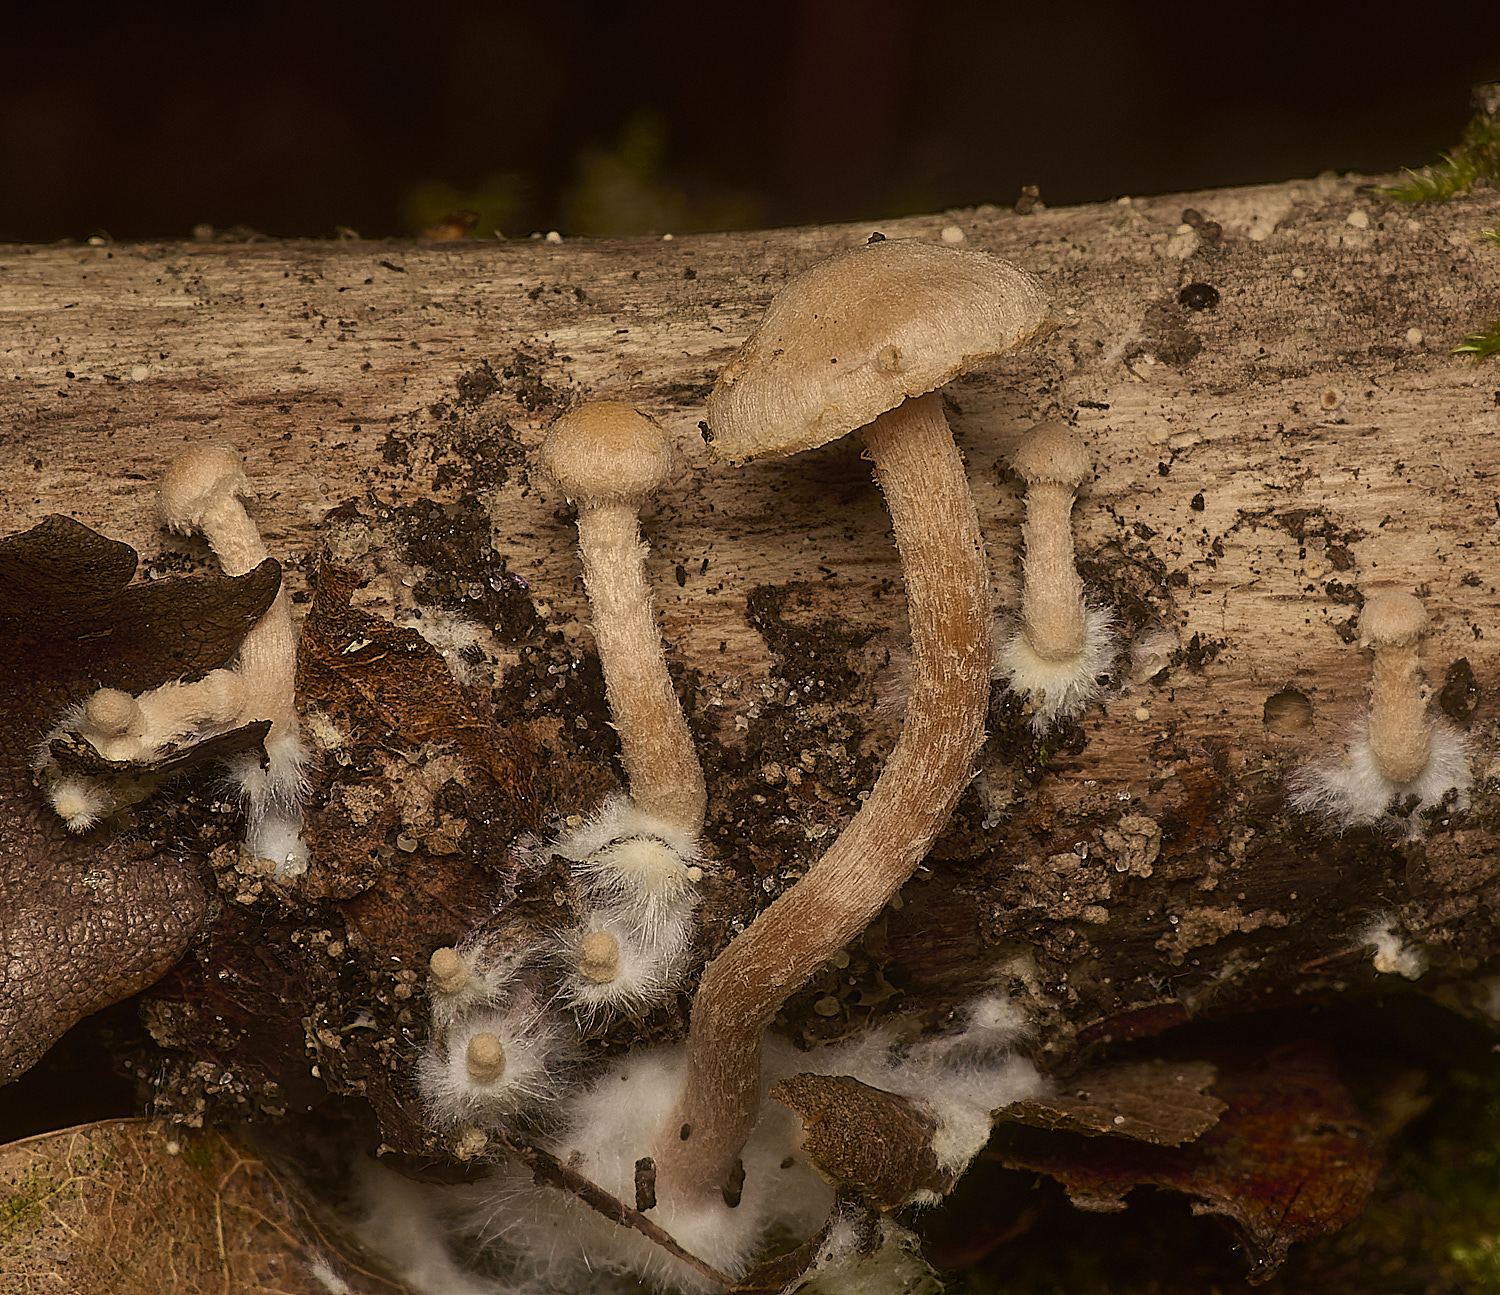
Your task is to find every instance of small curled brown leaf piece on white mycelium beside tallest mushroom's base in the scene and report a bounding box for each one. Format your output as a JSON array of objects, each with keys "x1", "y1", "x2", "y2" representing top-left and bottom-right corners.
[{"x1": 771, "y1": 1074, "x2": 956, "y2": 1209}]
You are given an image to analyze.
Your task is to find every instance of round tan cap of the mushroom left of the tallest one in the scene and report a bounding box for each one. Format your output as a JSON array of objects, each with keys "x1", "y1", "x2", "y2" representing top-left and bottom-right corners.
[{"x1": 537, "y1": 401, "x2": 678, "y2": 506}]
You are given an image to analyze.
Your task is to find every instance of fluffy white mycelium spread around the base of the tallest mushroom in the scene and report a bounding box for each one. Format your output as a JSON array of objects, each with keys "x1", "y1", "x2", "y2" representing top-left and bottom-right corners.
[{"x1": 360, "y1": 995, "x2": 1043, "y2": 1295}]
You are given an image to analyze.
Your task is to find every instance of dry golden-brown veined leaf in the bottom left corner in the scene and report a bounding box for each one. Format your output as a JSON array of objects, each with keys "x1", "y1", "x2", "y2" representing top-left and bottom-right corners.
[{"x1": 0, "y1": 1119, "x2": 408, "y2": 1295}]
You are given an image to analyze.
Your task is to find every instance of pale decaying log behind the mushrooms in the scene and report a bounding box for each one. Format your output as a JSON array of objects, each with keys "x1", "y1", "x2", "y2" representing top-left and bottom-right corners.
[{"x1": 0, "y1": 177, "x2": 1500, "y2": 1134}]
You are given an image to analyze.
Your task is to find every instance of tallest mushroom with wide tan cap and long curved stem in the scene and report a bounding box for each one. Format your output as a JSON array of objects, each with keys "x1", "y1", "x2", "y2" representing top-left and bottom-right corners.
[{"x1": 654, "y1": 240, "x2": 1049, "y2": 1200}]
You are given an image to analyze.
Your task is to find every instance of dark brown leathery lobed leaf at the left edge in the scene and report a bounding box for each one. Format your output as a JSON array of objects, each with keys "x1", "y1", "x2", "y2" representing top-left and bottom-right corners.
[{"x1": 0, "y1": 516, "x2": 281, "y2": 1082}]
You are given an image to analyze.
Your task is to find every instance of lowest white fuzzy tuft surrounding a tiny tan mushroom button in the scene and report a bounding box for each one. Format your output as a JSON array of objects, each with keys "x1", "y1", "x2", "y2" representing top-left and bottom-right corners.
[{"x1": 417, "y1": 987, "x2": 572, "y2": 1128}]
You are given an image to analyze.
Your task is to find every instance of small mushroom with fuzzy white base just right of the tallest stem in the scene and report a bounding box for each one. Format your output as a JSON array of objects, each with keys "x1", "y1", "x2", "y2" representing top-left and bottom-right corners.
[{"x1": 996, "y1": 423, "x2": 1115, "y2": 732}]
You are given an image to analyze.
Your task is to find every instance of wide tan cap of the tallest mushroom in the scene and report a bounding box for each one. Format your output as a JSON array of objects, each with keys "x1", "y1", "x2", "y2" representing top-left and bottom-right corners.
[{"x1": 708, "y1": 239, "x2": 1049, "y2": 464}]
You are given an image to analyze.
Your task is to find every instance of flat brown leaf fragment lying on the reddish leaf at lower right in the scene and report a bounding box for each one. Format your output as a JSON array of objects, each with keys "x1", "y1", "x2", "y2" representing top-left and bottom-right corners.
[{"x1": 999, "y1": 1058, "x2": 1224, "y2": 1146}]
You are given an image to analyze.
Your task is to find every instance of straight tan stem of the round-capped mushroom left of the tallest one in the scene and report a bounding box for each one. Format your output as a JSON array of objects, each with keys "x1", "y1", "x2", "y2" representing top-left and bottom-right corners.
[{"x1": 578, "y1": 501, "x2": 708, "y2": 836}]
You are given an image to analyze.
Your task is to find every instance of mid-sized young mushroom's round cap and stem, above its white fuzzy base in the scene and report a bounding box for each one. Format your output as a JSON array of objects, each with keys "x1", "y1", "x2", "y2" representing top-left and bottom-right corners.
[{"x1": 537, "y1": 401, "x2": 708, "y2": 837}]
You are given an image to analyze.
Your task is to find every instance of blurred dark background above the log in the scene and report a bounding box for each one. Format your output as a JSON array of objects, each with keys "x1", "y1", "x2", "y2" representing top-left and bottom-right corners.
[{"x1": 0, "y1": 0, "x2": 1500, "y2": 240}]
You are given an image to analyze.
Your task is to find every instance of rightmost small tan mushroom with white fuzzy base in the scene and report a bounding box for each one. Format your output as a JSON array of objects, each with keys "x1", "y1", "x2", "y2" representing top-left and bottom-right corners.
[{"x1": 1290, "y1": 591, "x2": 1472, "y2": 839}]
